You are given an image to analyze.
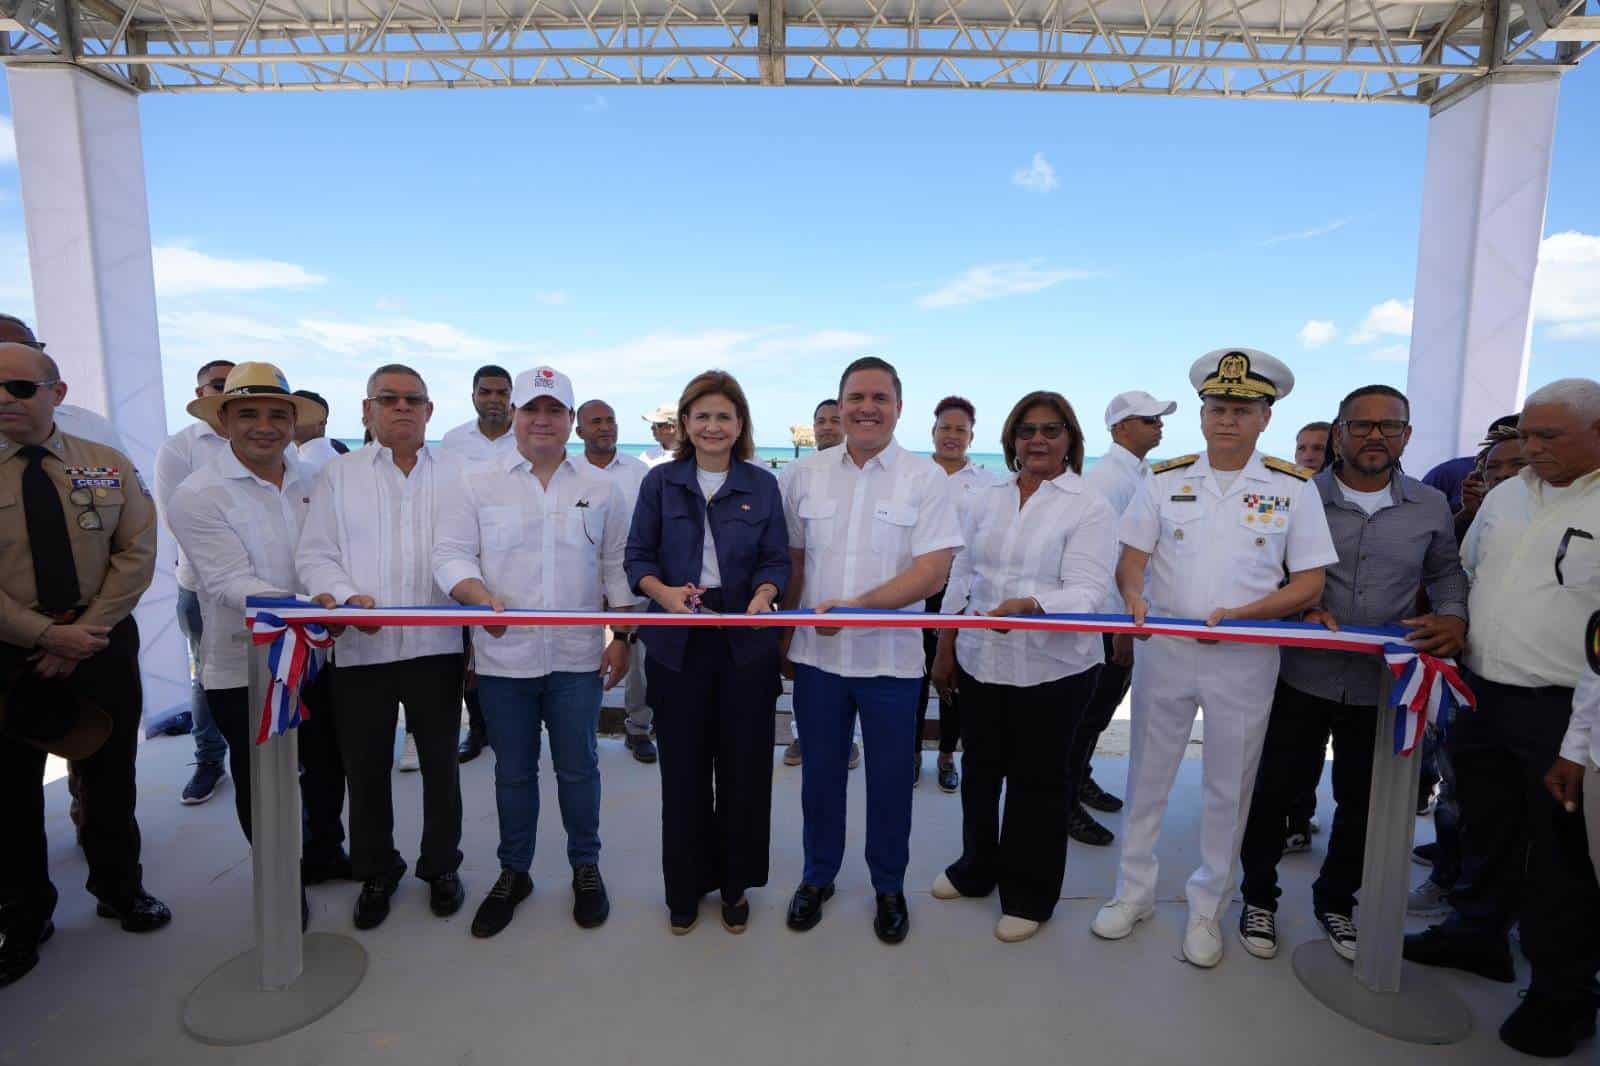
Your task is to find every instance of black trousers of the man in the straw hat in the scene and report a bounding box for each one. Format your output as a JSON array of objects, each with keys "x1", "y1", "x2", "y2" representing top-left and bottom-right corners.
[{"x1": 205, "y1": 666, "x2": 344, "y2": 864}]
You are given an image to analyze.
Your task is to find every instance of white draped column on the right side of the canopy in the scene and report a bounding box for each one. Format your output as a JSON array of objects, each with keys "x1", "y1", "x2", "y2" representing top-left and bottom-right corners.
[{"x1": 1406, "y1": 72, "x2": 1560, "y2": 472}]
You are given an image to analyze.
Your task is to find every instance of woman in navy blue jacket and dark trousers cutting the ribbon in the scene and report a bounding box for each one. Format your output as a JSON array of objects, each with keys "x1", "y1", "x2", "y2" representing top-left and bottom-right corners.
[{"x1": 624, "y1": 370, "x2": 790, "y2": 935}]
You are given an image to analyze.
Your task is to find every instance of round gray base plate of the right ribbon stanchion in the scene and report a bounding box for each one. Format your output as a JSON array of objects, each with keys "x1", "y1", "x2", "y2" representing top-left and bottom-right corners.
[{"x1": 1294, "y1": 940, "x2": 1472, "y2": 1044}]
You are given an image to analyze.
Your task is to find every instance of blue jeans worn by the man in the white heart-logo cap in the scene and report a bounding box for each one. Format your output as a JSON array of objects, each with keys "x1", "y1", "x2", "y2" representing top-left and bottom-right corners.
[{"x1": 478, "y1": 671, "x2": 600, "y2": 874}]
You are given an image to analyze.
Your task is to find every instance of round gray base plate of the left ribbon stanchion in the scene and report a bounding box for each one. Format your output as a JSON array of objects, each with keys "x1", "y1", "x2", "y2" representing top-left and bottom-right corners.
[{"x1": 184, "y1": 933, "x2": 366, "y2": 1047}]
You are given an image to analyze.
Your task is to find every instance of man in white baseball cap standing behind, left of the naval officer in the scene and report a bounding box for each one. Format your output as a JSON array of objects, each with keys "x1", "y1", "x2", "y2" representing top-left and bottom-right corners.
[{"x1": 1067, "y1": 389, "x2": 1178, "y2": 848}]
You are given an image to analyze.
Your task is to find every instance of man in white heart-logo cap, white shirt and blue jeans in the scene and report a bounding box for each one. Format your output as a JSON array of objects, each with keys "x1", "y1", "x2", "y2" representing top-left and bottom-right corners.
[{"x1": 434, "y1": 367, "x2": 634, "y2": 936}]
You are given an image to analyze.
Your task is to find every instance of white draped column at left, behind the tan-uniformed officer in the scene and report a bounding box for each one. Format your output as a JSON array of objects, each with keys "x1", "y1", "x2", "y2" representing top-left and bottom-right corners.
[{"x1": 6, "y1": 66, "x2": 189, "y2": 717}]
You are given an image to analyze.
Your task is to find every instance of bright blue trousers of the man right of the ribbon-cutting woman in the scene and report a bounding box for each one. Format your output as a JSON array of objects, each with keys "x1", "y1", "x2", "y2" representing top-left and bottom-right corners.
[{"x1": 794, "y1": 663, "x2": 922, "y2": 892}]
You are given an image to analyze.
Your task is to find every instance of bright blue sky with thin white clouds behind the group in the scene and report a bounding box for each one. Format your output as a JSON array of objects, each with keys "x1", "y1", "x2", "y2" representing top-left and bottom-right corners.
[{"x1": 0, "y1": 62, "x2": 1600, "y2": 453}]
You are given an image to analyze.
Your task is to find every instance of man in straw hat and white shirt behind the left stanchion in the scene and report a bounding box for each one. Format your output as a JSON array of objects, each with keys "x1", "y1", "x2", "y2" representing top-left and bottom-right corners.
[{"x1": 166, "y1": 363, "x2": 350, "y2": 884}]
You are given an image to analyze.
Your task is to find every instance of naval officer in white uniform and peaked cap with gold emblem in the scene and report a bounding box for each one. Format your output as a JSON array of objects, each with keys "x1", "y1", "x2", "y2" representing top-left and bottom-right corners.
[{"x1": 1091, "y1": 347, "x2": 1339, "y2": 967}]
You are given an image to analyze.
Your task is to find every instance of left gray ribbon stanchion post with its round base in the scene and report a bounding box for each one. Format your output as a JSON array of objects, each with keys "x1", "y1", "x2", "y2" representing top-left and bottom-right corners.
[{"x1": 184, "y1": 633, "x2": 366, "y2": 1045}]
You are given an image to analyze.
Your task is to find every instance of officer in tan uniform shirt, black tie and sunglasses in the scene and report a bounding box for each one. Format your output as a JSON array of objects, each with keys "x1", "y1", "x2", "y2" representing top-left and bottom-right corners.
[{"x1": 0, "y1": 344, "x2": 173, "y2": 986}]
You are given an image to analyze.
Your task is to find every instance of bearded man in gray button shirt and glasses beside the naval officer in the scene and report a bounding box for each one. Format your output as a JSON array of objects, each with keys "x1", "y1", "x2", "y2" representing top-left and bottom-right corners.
[{"x1": 1238, "y1": 386, "x2": 1467, "y2": 959}]
